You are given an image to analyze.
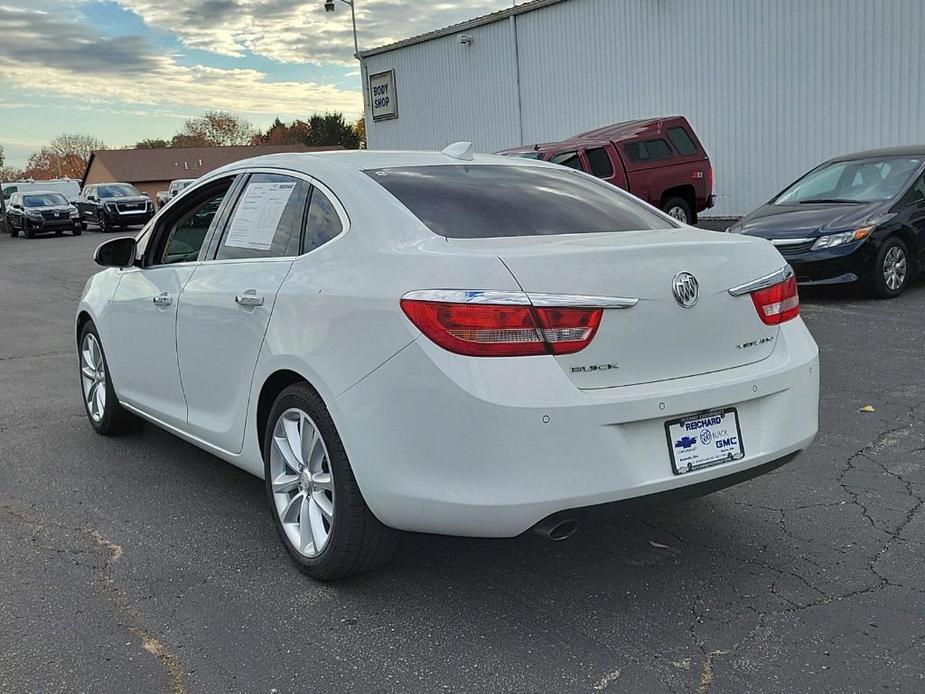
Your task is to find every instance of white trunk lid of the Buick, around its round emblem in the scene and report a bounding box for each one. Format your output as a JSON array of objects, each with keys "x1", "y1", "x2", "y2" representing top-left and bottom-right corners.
[{"x1": 449, "y1": 229, "x2": 784, "y2": 389}]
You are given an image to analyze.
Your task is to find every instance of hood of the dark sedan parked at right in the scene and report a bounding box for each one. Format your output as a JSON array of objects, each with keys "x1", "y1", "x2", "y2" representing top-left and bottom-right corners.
[{"x1": 735, "y1": 202, "x2": 885, "y2": 239}]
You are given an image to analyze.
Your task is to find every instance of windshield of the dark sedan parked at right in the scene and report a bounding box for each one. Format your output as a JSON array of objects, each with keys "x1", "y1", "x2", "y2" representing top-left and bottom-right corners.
[{"x1": 774, "y1": 157, "x2": 922, "y2": 205}]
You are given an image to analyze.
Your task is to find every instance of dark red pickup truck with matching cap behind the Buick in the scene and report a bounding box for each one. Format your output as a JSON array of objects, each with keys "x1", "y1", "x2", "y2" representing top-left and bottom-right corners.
[{"x1": 498, "y1": 116, "x2": 715, "y2": 224}]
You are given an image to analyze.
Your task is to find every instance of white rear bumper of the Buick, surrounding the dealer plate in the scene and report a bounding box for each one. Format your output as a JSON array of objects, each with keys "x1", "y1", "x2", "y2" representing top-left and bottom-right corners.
[{"x1": 332, "y1": 320, "x2": 819, "y2": 537}]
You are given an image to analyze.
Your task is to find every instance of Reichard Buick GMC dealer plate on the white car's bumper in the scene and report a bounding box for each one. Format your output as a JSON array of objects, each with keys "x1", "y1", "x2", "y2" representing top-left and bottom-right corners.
[{"x1": 665, "y1": 407, "x2": 745, "y2": 475}]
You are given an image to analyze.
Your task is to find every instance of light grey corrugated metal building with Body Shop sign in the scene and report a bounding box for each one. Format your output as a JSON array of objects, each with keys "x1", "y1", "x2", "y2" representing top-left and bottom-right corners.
[{"x1": 361, "y1": 0, "x2": 925, "y2": 216}]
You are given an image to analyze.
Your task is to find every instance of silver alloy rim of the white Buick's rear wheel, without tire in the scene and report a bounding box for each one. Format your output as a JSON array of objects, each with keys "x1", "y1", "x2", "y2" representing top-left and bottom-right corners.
[{"x1": 269, "y1": 408, "x2": 334, "y2": 557}]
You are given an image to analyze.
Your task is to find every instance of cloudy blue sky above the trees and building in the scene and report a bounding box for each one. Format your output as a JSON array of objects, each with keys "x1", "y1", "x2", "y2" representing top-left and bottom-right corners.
[{"x1": 0, "y1": 0, "x2": 512, "y2": 166}]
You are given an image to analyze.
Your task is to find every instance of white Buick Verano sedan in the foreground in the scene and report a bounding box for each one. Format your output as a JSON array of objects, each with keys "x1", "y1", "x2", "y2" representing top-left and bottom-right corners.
[{"x1": 77, "y1": 144, "x2": 819, "y2": 579}]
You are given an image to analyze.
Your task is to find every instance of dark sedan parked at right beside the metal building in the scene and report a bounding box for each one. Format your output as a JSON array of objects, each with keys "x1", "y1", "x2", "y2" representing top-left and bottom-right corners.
[{"x1": 729, "y1": 146, "x2": 925, "y2": 299}]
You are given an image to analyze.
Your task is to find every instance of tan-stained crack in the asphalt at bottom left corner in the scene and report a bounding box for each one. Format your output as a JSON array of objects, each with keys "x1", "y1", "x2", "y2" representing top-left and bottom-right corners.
[{"x1": 0, "y1": 505, "x2": 187, "y2": 694}]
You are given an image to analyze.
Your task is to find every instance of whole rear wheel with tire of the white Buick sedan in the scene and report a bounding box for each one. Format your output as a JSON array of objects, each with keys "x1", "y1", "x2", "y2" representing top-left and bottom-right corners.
[{"x1": 263, "y1": 383, "x2": 398, "y2": 581}]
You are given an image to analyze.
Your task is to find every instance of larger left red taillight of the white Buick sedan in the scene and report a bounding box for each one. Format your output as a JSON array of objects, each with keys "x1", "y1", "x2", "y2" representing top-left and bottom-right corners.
[{"x1": 401, "y1": 299, "x2": 603, "y2": 357}]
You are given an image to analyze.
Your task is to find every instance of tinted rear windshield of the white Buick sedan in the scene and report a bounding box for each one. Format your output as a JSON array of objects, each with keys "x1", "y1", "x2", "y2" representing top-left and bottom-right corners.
[{"x1": 365, "y1": 164, "x2": 672, "y2": 239}]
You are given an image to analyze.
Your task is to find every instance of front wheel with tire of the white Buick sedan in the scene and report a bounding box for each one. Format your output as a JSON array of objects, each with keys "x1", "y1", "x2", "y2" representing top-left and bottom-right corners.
[{"x1": 77, "y1": 321, "x2": 144, "y2": 436}]
